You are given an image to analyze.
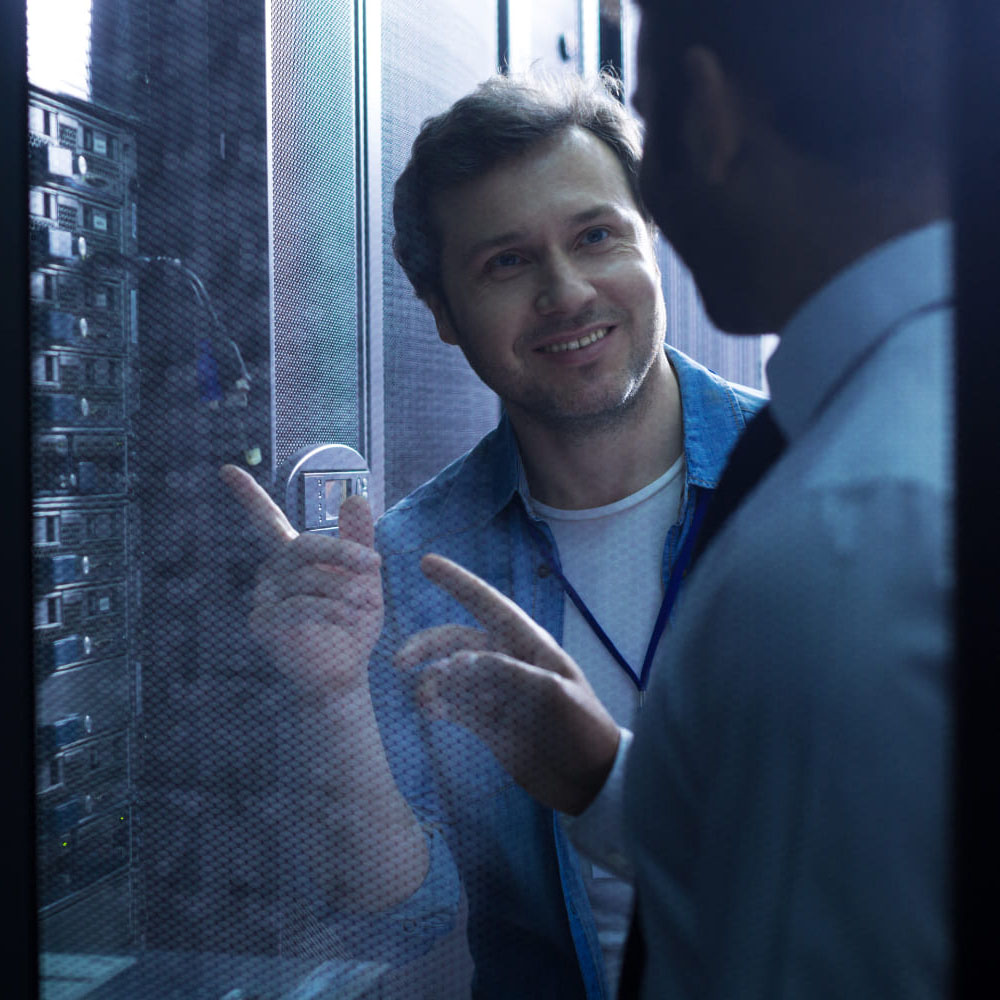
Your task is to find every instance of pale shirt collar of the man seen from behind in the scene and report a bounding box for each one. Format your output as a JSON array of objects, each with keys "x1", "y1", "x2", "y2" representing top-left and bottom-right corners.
[{"x1": 767, "y1": 221, "x2": 952, "y2": 440}]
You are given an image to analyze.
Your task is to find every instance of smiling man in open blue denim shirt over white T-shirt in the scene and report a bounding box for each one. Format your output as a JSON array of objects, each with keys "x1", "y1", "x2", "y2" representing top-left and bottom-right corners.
[{"x1": 226, "y1": 75, "x2": 762, "y2": 998}]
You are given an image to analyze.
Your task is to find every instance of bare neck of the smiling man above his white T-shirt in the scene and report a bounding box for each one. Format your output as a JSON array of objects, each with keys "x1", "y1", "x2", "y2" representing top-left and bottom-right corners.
[{"x1": 510, "y1": 354, "x2": 684, "y2": 510}]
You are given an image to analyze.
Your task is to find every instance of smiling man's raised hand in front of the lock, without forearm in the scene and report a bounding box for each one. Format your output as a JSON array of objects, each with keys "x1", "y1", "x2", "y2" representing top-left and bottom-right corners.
[{"x1": 220, "y1": 465, "x2": 383, "y2": 696}]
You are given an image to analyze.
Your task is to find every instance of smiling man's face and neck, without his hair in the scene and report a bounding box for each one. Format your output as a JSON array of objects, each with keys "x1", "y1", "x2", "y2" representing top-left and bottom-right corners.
[{"x1": 418, "y1": 125, "x2": 682, "y2": 508}]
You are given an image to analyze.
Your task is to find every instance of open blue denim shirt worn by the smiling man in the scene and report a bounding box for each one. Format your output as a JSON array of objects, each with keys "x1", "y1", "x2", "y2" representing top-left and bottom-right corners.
[{"x1": 370, "y1": 347, "x2": 764, "y2": 998}]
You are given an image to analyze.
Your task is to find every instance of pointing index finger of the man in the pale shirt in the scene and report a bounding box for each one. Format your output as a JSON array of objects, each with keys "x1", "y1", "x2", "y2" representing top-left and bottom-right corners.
[{"x1": 420, "y1": 553, "x2": 567, "y2": 673}]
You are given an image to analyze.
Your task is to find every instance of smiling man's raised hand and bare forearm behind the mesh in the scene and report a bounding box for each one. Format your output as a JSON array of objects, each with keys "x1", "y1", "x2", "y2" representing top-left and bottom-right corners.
[{"x1": 220, "y1": 465, "x2": 428, "y2": 912}]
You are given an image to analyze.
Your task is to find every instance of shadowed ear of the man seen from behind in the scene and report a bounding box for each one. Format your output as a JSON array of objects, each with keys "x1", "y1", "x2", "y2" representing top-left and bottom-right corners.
[{"x1": 682, "y1": 45, "x2": 745, "y2": 186}]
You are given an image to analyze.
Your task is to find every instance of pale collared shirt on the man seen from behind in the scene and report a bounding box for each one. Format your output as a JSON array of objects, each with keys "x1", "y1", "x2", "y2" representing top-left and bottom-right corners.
[{"x1": 625, "y1": 223, "x2": 953, "y2": 1000}]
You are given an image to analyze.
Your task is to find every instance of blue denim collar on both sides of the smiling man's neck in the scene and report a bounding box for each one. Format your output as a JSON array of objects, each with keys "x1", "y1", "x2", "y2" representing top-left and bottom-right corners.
[{"x1": 469, "y1": 345, "x2": 746, "y2": 520}]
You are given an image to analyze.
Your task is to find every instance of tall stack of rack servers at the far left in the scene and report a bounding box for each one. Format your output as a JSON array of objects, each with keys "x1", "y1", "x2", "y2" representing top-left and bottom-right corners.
[{"x1": 28, "y1": 90, "x2": 140, "y2": 951}]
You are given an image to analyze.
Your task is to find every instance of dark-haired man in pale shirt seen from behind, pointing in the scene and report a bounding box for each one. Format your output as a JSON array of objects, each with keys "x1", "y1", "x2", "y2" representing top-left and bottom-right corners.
[{"x1": 411, "y1": 0, "x2": 954, "y2": 1000}]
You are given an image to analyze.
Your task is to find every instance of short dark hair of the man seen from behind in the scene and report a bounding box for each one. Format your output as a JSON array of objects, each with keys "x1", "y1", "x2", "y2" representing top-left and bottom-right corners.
[{"x1": 639, "y1": 0, "x2": 948, "y2": 163}]
